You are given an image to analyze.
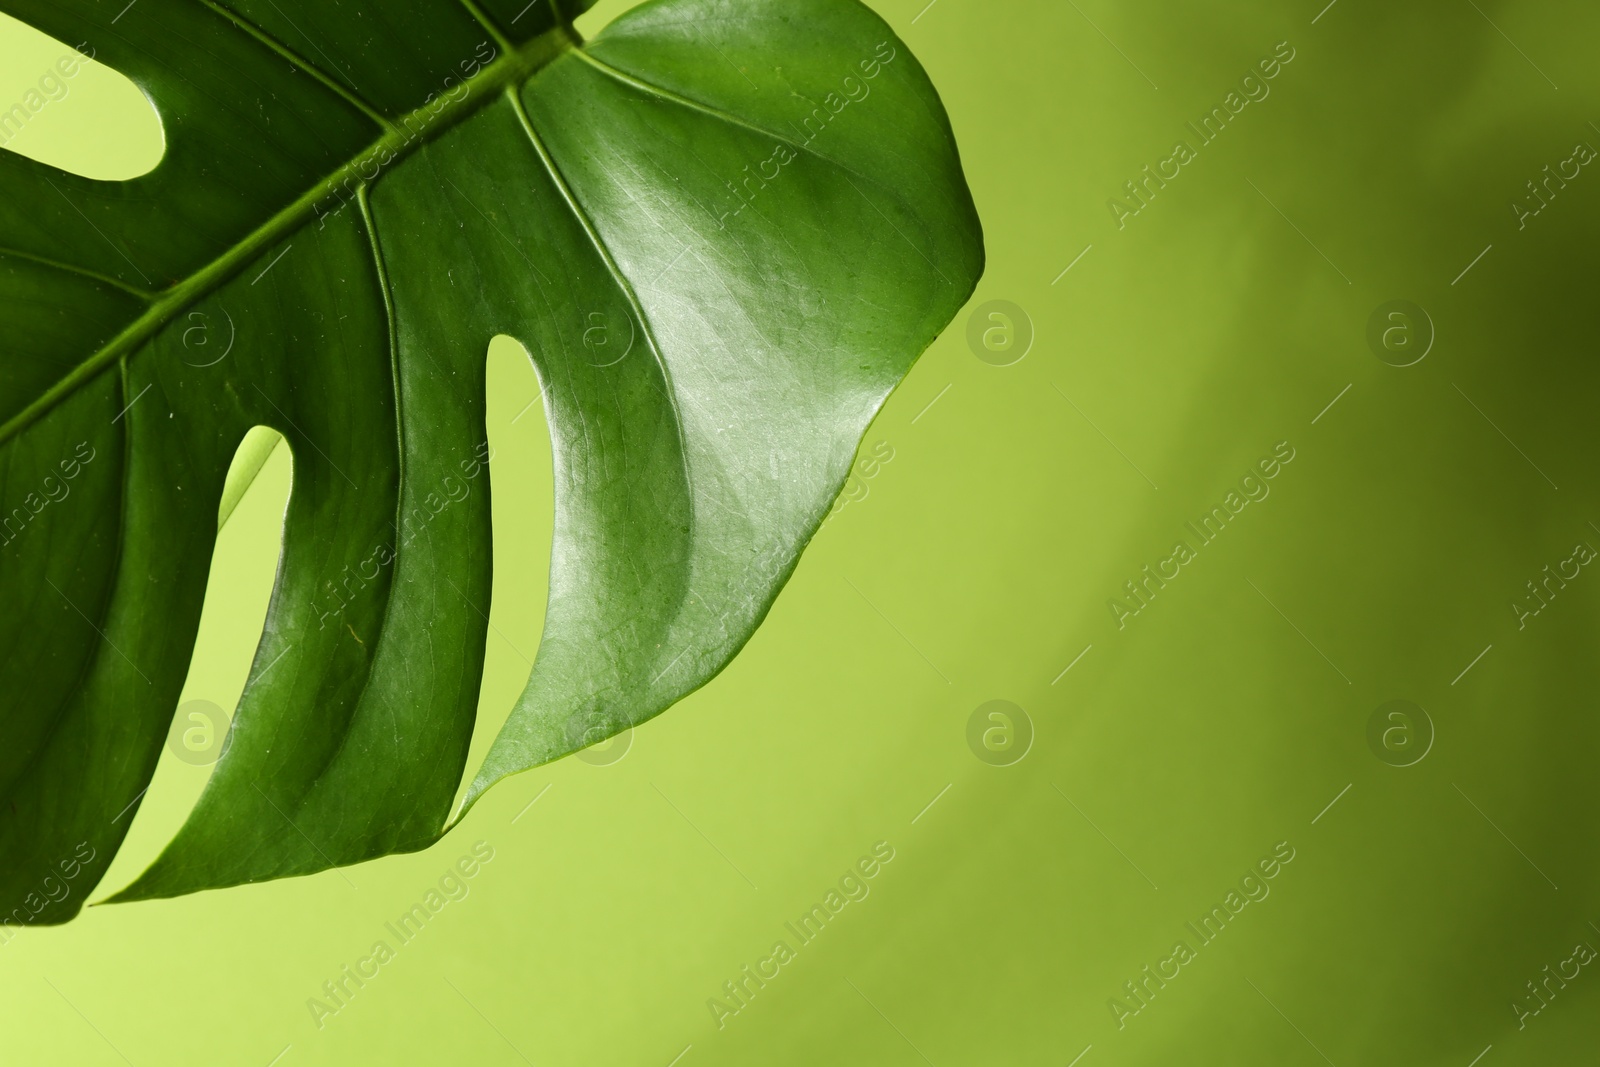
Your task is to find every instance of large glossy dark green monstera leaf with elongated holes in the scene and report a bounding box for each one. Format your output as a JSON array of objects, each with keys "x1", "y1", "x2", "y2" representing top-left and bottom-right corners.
[{"x1": 0, "y1": 0, "x2": 982, "y2": 921}]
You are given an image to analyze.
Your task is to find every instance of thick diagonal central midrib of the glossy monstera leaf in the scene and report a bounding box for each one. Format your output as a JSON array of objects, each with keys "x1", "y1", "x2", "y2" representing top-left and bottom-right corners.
[{"x1": 0, "y1": 22, "x2": 582, "y2": 446}]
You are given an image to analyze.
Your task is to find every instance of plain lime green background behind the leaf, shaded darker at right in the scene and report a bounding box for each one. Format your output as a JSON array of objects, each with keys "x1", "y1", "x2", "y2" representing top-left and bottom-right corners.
[{"x1": 0, "y1": 0, "x2": 1600, "y2": 1067}]
